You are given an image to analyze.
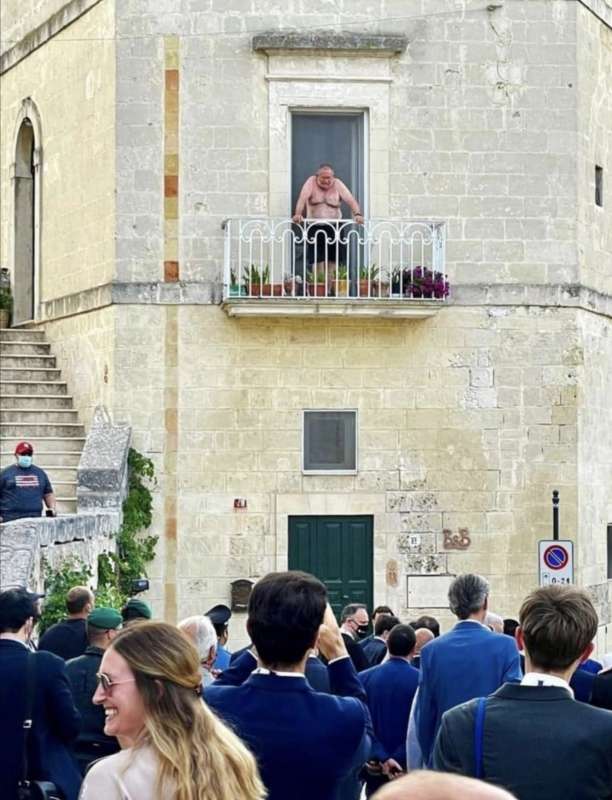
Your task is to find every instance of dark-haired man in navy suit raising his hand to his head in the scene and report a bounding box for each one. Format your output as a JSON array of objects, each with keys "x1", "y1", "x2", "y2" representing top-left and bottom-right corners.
[{"x1": 204, "y1": 572, "x2": 371, "y2": 800}]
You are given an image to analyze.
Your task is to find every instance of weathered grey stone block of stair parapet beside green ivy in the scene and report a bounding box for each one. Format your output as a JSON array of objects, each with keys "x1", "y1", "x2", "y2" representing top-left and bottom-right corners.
[{"x1": 77, "y1": 406, "x2": 131, "y2": 514}]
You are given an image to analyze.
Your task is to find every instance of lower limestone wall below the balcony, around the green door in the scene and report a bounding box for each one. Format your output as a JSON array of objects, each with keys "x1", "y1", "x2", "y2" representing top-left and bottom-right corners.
[{"x1": 177, "y1": 307, "x2": 584, "y2": 632}]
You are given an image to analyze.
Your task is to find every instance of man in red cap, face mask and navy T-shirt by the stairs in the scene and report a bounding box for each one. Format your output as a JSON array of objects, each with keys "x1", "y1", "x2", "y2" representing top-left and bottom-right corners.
[{"x1": 0, "y1": 442, "x2": 56, "y2": 522}]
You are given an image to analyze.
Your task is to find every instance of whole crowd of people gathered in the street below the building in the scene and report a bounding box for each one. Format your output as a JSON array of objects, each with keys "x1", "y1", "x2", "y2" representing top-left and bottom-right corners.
[{"x1": 0, "y1": 571, "x2": 612, "y2": 800}]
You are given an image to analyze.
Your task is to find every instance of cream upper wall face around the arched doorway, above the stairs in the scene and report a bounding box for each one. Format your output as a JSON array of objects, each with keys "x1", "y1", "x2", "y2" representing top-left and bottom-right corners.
[{"x1": 0, "y1": 0, "x2": 115, "y2": 301}]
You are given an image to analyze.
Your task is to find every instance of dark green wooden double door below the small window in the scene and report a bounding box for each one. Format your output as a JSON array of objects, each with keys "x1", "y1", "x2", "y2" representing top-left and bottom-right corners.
[{"x1": 289, "y1": 516, "x2": 373, "y2": 616}]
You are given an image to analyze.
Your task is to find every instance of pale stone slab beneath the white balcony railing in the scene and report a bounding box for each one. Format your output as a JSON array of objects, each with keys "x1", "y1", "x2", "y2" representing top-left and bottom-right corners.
[{"x1": 222, "y1": 297, "x2": 445, "y2": 319}]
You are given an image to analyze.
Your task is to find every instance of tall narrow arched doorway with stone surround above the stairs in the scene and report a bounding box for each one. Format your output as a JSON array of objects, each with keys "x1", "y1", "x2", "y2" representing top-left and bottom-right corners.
[{"x1": 11, "y1": 97, "x2": 42, "y2": 325}]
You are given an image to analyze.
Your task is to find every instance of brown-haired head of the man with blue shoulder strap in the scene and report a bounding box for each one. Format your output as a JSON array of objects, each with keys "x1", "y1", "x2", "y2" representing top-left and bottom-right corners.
[{"x1": 517, "y1": 586, "x2": 597, "y2": 672}]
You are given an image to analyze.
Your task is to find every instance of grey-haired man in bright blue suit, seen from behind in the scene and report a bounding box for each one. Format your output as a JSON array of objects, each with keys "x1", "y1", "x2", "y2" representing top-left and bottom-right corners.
[{"x1": 409, "y1": 574, "x2": 522, "y2": 766}]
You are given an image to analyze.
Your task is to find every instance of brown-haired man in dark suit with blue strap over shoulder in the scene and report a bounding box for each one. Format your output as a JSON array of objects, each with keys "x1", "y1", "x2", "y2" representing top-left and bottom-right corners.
[{"x1": 434, "y1": 585, "x2": 612, "y2": 800}]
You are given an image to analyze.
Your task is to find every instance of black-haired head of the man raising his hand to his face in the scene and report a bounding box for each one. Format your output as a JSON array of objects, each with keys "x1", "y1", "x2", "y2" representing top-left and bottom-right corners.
[{"x1": 247, "y1": 571, "x2": 327, "y2": 669}]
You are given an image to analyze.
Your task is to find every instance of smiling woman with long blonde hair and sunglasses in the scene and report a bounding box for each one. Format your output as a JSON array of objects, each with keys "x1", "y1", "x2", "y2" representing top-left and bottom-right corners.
[{"x1": 80, "y1": 622, "x2": 266, "y2": 800}]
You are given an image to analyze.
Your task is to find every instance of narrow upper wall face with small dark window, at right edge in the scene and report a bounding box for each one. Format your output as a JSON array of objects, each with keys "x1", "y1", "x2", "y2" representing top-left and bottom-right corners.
[{"x1": 576, "y1": 4, "x2": 612, "y2": 294}]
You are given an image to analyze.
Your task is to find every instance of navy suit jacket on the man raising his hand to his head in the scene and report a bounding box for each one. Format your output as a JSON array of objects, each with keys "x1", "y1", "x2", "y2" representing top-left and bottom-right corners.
[{"x1": 204, "y1": 658, "x2": 371, "y2": 800}]
